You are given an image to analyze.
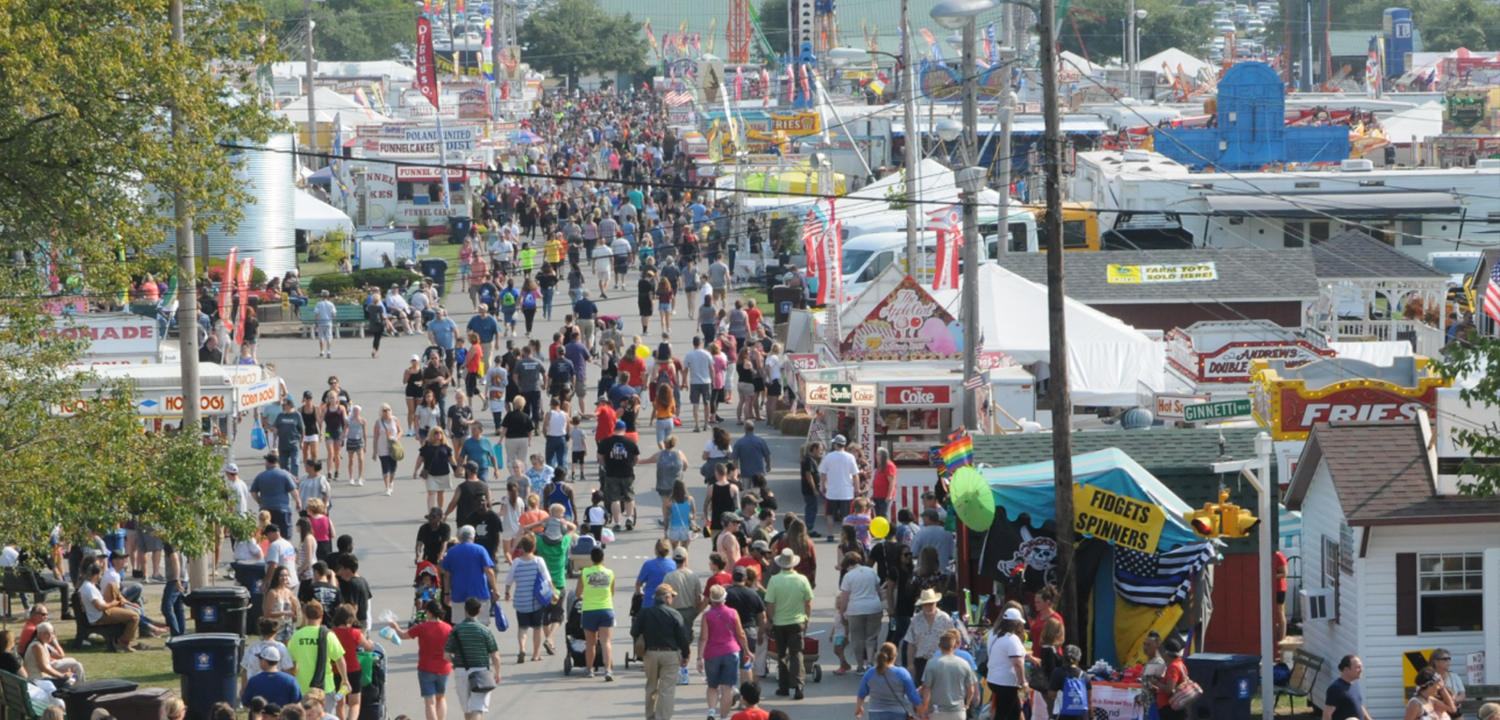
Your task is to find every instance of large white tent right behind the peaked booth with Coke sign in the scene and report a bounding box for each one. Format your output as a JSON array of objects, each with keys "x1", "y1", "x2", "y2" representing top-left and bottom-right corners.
[{"x1": 947, "y1": 264, "x2": 1166, "y2": 407}]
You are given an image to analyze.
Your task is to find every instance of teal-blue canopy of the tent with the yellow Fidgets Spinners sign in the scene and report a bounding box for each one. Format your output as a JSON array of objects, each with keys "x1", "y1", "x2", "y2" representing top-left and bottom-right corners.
[{"x1": 980, "y1": 447, "x2": 1203, "y2": 552}]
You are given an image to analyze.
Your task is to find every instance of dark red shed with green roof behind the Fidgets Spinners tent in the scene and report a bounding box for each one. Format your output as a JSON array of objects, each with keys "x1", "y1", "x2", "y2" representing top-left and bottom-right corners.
[{"x1": 974, "y1": 426, "x2": 1295, "y2": 654}]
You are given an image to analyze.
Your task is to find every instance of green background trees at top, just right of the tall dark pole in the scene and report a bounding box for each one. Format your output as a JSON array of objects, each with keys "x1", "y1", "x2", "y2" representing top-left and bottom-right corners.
[{"x1": 1058, "y1": 0, "x2": 1214, "y2": 63}]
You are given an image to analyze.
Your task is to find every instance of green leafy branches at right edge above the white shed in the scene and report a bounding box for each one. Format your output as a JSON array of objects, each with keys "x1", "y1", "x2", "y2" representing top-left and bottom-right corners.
[{"x1": 1433, "y1": 335, "x2": 1500, "y2": 498}]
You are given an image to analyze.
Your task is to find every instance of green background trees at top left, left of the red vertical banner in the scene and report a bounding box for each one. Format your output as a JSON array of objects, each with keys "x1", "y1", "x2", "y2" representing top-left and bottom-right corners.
[{"x1": 261, "y1": 0, "x2": 417, "y2": 62}]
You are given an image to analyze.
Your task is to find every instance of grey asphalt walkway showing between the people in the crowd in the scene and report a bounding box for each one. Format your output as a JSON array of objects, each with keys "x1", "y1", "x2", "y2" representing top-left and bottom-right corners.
[{"x1": 228, "y1": 272, "x2": 858, "y2": 720}]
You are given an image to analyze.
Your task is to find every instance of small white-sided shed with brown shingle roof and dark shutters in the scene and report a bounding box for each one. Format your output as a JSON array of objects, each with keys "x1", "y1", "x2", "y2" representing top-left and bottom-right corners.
[{"x1": 1286, "y1": 422, "x2": 1500, "y2": 717}]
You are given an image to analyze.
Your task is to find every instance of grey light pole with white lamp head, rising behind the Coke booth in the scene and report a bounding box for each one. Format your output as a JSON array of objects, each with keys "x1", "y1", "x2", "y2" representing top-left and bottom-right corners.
[{"x1": 929, "y1": 0, "x2": 999, "y2": 431}]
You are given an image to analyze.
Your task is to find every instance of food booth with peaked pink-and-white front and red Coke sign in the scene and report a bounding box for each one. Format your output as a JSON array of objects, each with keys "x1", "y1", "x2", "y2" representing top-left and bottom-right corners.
[{"x1": 788, "y1": 270, "x2": 1035, "y2": 509}]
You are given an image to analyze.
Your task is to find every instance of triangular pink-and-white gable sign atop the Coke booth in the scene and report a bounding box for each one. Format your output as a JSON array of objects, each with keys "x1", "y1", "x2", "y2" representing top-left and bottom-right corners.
[{"x1": 839, "y1": 276, "x2": 963, "y2": 366}]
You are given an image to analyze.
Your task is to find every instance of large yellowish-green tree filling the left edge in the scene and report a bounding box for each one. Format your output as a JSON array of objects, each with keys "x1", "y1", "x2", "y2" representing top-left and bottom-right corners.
[{"x1": 0, "y1": 0, "x2": 279, "y2": 554}]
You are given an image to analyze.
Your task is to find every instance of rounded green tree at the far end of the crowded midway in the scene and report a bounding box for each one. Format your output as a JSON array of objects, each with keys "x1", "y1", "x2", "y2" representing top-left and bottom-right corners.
[{"x1": 519, "y1": 0, "x2": 651, "y2": 87}]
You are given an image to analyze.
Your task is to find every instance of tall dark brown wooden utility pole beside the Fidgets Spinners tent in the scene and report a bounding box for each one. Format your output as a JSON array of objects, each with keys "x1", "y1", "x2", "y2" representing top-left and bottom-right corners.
[{"x1": 1037, "y1": 0, "x2": 1080, "y2": 636}]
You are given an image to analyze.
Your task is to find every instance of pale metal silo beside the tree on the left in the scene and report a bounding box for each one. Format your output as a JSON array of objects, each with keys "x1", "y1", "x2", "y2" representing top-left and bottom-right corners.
[{"x1": 200, "y1": 134, "x2": 297, "y2": 276}]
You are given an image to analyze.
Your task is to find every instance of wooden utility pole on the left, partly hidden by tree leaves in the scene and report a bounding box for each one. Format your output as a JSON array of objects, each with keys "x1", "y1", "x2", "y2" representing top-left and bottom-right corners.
[{"x1": 167, "y1": 0, "x2": 207, "y2": 588}]
